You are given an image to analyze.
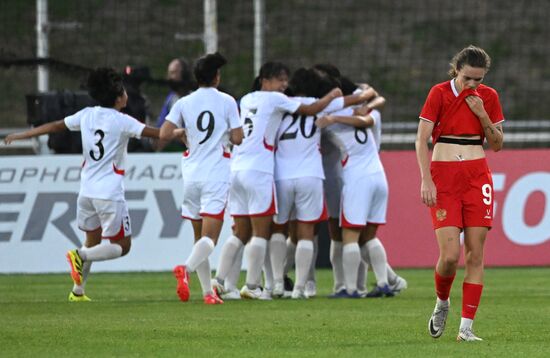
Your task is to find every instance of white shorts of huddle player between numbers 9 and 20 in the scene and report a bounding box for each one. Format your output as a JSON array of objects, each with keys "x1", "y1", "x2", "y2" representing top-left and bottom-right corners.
[{"x1": 229, "y1": 170, "x2": 277, "y2": 217}]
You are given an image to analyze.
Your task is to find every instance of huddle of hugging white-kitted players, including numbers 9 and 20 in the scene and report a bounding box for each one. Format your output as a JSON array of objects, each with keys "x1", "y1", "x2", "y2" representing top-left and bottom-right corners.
[{"x1": 160, "y1": 53, "x2": 406, "y2": 304}]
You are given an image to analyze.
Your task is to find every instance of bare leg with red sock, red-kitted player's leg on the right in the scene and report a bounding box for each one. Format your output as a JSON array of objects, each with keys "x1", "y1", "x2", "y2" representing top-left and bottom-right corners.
[{"x1": 457, "y1": 227, "x2": 488, "y2": 341}]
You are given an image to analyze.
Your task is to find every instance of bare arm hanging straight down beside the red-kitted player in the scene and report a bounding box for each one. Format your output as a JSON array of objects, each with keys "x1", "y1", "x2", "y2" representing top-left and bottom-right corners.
[{"x1": 414, "y1": 119, "x2": 437, "y2": 207}]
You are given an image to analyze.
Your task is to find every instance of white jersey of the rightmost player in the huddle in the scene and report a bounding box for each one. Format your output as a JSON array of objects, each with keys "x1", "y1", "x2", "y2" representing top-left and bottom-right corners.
[{"x1": 325, "y1": 108, "x2": 384, "y2": 176}]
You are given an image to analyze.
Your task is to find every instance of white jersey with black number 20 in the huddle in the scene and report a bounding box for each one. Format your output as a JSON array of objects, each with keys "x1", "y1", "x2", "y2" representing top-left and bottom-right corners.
[{"x1": 275, "y1": 97, "x2": 344, "y2": 180}]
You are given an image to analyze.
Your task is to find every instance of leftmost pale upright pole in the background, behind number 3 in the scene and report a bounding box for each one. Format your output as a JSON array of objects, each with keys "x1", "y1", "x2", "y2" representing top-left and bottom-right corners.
[{"x1": 36, "y1": 0, "x2": 50, "y2": 92}]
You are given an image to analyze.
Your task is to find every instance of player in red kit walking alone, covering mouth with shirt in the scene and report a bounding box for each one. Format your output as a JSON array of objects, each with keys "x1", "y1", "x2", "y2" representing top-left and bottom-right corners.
[{"x1": 415, "y1": 46, "x2": 504, "y2": 341}]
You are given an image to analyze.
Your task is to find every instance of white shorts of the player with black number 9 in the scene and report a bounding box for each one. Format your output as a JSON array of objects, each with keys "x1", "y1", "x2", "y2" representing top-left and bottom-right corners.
[{"x1": 181, "y1": 180, "x2": 229, "y2": 220}]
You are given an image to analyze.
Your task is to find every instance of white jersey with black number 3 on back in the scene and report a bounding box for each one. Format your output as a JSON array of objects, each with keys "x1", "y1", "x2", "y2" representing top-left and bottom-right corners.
[{"x1": 65, "y1": 106, "x2": 145, "y2": 201}]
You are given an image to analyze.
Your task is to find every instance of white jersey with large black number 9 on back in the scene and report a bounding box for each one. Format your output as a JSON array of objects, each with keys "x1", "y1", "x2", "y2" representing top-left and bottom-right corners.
[{"x1": 166, "y1": 87, "x2": 241, "y2": 182}]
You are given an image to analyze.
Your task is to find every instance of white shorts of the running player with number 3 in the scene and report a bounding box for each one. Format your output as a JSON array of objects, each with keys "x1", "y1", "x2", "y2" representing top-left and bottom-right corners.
[{"x1": 76, "y1": 196, "x2": 132, "y2": 240}]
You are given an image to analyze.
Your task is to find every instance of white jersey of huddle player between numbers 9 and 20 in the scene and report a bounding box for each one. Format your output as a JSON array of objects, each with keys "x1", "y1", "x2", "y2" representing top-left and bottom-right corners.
[{"x1": 231, "y1": 91, "x2": 301, "y2": 174}]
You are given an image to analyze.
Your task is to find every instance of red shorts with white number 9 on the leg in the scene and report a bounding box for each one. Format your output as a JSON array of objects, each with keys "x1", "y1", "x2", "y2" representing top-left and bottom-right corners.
[{"x1": 430, "y1": 158, "x2": 494, "y2": 229}]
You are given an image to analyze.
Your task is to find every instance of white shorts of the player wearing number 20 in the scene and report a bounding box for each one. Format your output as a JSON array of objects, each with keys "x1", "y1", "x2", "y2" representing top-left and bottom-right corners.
[{"x1": 273, "y1": 177, "x2": 328, "y2": 224}]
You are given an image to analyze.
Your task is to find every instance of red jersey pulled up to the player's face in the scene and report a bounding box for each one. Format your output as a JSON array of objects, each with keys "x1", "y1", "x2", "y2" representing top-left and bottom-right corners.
[{"x1": 420, "y1": 79, "x2": 504, "y2": 144}]
